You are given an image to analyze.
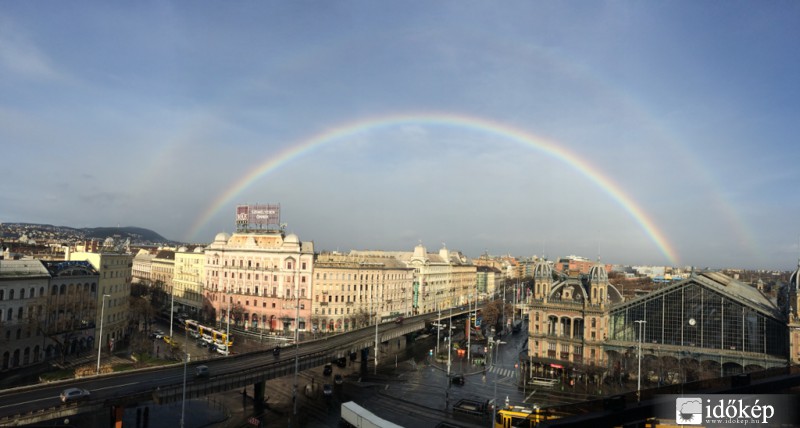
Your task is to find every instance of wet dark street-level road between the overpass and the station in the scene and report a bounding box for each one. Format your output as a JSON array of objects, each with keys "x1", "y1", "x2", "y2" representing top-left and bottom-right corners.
[{"x1": 209, "y1": 322, "x2": 581, "y2": 428}]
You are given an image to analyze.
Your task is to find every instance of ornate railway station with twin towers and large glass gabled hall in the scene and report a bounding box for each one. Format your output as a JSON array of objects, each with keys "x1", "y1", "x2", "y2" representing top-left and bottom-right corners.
[{"x1": 528, "y1": 263, "x2": 800, "y2": 384}]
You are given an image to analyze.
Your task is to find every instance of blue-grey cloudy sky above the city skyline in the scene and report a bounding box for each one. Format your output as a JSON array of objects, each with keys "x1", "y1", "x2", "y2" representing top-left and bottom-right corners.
[{"x1": 0, "y1": 0, "x2": 800, "y2": 269}]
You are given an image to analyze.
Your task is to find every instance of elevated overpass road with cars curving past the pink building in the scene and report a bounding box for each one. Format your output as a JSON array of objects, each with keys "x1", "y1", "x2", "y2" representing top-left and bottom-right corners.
[{"x1": 0, "y1": 309, "x2": 438, "y2": 427}]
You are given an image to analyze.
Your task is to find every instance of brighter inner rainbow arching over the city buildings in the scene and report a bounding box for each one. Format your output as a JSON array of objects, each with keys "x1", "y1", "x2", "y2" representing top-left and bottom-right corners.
[{"x1": 189, "y1": 113, "x2": 677, "y2": 266}]
